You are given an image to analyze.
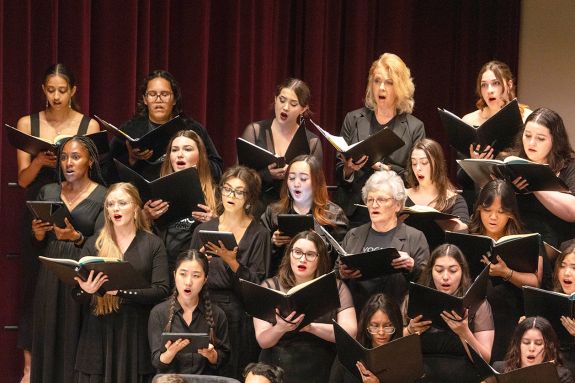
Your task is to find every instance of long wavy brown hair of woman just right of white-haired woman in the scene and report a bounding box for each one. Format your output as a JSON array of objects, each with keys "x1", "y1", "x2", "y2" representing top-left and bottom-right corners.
[{"x1": 405, "y1": 138, "x2": 455, "y2": 211}]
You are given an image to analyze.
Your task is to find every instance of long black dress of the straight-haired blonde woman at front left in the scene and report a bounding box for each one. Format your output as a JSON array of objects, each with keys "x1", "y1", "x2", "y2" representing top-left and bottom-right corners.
[{"x1": 75, "y1": 231, "x2": 168, "y2": 383}]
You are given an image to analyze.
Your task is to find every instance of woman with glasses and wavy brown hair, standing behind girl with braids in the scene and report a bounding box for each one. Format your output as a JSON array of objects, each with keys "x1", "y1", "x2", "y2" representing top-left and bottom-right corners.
[{"x1": 191, "y1": 166, "x2": 270, "y2": 379}]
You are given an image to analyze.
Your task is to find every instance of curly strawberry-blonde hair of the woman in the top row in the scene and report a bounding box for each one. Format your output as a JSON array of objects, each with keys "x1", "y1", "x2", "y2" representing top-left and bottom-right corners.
[{"x1": 365, "y1": 53, "x2": 415, "y2": 113}]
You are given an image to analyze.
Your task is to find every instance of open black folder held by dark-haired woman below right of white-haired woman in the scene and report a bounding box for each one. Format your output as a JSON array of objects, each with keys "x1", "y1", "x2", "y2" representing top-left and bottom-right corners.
[{"x1": 407, "y1": 266, "x2": 489, "y2": 328}]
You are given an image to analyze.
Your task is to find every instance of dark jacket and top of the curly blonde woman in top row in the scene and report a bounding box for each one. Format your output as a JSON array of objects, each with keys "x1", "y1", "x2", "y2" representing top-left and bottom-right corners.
[{"x1": 335, "y1": 108, "x2": 425, "y2": 222}]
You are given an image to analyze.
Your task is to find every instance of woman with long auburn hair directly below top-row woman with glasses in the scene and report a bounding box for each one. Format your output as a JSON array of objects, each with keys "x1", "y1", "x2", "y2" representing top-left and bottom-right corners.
[{"x1": 144, "y1": 130, "x2": 216, "y2": 286}]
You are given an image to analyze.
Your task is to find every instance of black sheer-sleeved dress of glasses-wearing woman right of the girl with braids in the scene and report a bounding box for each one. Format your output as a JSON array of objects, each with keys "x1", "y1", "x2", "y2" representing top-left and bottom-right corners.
[{"x1": 260, "y1": 277, "x2": 353, "y2": 383}]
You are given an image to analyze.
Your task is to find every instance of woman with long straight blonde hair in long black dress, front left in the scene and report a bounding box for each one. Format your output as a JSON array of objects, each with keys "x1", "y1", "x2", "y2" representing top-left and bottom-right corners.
[{"x1": 73, "y1": 182, "x2": 169, "y2": 383}]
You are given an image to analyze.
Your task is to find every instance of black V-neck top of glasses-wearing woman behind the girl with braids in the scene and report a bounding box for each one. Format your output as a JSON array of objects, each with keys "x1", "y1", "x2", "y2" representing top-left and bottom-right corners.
[{"x1": 190, "y1": 218, "x2": 270, "y2": 294}]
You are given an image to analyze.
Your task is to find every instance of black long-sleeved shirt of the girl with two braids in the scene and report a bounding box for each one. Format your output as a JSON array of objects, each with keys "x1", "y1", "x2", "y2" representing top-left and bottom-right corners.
[{"x1": 148, "y1": 299, "x2": 230, "y2": 375}]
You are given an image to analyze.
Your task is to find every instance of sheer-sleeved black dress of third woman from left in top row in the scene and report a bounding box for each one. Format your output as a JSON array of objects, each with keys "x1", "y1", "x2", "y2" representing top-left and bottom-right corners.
[{"x1": 241, "y1": 120, "x2": 323, "y2": 217}]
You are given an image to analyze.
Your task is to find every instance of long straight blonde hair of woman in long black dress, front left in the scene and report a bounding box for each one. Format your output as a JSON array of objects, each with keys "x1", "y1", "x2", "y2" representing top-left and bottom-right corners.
[{"x1": 92, "y1": 182, "x2": 150, "y2": 315}]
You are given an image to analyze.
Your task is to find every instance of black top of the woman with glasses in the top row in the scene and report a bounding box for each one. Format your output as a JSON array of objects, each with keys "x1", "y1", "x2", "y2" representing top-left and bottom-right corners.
[{"x1": 107, "y1": 116, "x2": 224, "y2": 183}]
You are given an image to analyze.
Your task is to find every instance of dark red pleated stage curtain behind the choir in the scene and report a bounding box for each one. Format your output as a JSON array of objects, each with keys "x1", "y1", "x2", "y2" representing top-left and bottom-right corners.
[{"x1": 0, "y1": 0, "x2": 520, "y2": 380}]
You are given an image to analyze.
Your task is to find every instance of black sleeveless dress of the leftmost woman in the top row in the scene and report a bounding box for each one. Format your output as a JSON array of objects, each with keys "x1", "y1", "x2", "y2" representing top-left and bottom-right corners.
[{"x1": 18, "y1": 113, "x2": 90, "y2": 350}]
